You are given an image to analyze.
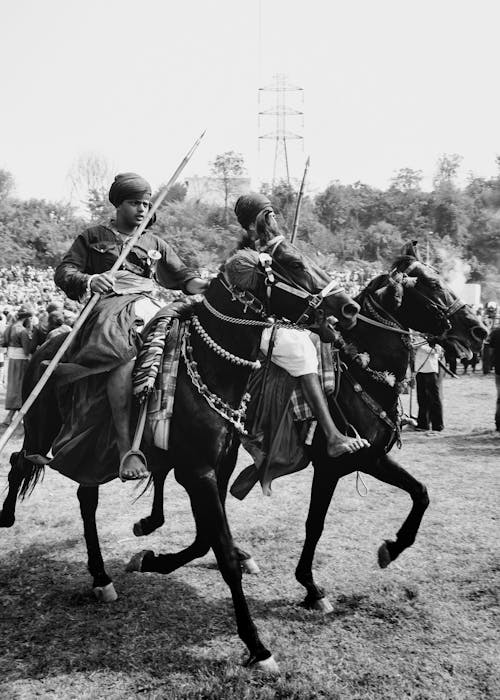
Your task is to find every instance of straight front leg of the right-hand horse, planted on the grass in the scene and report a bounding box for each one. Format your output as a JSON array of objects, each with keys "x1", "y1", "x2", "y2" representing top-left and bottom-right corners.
[{"x1": 295, "y1": 464, "x2": 338, "y2": 612}]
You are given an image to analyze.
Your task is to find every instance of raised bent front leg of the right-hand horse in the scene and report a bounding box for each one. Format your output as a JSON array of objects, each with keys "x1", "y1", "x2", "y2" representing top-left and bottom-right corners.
[{"x1": 363, "y1": 455, "x2": 429, "y2": 569}]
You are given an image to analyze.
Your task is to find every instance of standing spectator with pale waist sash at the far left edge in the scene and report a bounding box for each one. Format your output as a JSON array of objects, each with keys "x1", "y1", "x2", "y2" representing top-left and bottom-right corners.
[{"x1": 4, "y1": 305, "x2": 34, "y2": 425}]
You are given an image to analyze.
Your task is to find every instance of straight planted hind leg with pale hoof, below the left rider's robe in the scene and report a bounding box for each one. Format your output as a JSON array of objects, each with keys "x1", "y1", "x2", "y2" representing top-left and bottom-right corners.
[{"x1": 77, "y1": 486, "x2": 118, "y2": 603}]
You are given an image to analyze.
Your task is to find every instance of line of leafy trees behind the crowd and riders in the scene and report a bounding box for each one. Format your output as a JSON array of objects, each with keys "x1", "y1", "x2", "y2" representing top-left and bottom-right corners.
[{"x1": 0, "y1": 151, "x2": 500, "y2": 301}]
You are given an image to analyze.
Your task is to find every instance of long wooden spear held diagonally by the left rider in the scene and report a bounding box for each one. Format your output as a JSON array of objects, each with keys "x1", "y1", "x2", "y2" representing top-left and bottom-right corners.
[{"x1": 0, "y1": 130, "x2": 206, "y2": 453}]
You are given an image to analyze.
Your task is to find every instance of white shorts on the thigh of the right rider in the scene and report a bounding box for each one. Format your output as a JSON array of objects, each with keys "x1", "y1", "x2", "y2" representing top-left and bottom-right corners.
[{"x1": 260, "y1": 328, "x2": 318, "y2": 377}]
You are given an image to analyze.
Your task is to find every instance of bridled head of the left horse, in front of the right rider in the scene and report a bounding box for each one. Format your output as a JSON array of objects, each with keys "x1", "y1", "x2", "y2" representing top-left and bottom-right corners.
[{"x1": 239, "y1": 210, "x2": 359, "y2": 329}]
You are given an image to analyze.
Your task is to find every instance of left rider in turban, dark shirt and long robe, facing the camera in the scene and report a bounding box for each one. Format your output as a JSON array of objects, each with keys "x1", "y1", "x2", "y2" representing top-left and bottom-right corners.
[{"x1": 51, "y1": 173, "x2": 208, "y2": 485}]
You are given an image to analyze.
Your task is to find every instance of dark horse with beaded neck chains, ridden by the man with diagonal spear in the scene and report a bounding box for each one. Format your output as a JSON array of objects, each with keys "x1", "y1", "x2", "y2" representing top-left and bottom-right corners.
[{"x1": 0, "y1": 215, "x2": 359, "y2": 671}]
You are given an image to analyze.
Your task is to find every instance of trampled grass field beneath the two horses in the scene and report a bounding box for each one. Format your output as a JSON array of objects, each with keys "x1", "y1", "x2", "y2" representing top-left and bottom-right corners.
[{"x1": 0, "y1": 374, "x2": 500, "y2": 700}]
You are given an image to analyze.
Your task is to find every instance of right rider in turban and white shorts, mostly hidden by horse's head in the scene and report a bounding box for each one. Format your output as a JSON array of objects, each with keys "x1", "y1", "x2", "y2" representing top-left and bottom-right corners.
[{"x1": 234, "y1": 192, "x2": 369, "y2": 457}]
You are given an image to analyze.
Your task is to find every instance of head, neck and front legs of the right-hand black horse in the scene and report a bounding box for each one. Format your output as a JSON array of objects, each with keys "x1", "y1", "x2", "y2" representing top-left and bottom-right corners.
[{"x1": 295, "y1": 251, "x2": 487, "y2": 611}]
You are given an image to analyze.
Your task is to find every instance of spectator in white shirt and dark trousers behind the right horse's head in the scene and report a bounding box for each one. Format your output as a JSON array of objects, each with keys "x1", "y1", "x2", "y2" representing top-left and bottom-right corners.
[{"x1": 415, "y1": 340, "x2": 444, "y2": 431}]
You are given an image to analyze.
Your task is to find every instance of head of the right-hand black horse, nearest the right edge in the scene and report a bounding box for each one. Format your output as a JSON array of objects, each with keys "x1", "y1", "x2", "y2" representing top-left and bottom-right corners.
[{"x1": 391, "y1": 242, "x2": 488, "y2": 359}]
